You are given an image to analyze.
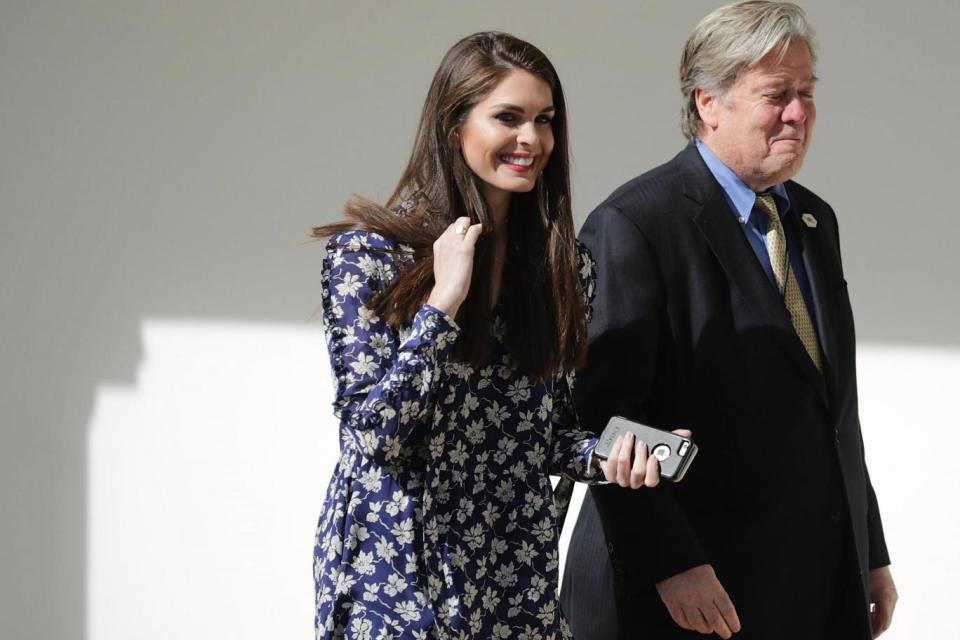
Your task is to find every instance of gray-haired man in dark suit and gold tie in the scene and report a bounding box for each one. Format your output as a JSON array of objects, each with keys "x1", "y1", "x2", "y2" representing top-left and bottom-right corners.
[{"x1": 562, "y1": 2, "x2": 897, "y2": 640}]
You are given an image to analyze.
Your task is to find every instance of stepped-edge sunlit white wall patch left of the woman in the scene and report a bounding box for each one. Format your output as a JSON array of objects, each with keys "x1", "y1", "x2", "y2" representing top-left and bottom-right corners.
[{"x1": 87, "y1": 319, "x2": 326, "y2": 640}]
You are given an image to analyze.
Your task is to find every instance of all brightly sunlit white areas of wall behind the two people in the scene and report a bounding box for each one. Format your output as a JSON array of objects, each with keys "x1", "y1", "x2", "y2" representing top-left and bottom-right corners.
[{"x1": 87, "y1": 319, "x2": 960, "y2": 640}]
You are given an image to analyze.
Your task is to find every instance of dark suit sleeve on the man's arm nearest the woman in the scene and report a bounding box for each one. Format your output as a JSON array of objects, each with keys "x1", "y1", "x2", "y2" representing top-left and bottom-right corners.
[{"x1": 575, "y1": 204, "x2": 707, "y2": 588}]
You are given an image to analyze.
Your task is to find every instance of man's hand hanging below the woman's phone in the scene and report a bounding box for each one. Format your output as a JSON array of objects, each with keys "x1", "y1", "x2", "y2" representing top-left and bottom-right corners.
[{"x1": 657, "y1": 564, "x2": 740, "y2": 638}]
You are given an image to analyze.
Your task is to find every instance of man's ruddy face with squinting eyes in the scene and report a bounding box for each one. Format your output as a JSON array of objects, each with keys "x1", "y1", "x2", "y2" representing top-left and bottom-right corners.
[{"x1": 697, "y1": 42, "x2": 817, "y2": 191}]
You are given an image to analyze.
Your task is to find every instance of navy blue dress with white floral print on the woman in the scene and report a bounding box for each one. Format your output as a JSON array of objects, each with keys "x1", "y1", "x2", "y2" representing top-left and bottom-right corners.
[{"x1": 314, "y1": 231, "x2": 602, "y2": 640}]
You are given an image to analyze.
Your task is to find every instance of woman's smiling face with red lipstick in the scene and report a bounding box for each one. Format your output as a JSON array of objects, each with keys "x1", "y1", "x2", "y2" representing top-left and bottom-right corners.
[{"x1": 460, "y1": 69, "x2": 555, "y2": 206}]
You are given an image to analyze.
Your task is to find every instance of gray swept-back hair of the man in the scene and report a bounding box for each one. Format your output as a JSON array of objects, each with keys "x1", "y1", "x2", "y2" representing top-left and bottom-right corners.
[{"x1": 680, "y1": 0, "x2": 817, "y2": 140}]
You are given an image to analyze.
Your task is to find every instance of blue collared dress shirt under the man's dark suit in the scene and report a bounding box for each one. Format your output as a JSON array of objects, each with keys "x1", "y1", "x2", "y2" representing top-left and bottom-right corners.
[{"x1": 694, "y1": 139, "x2": 819, "y2": 330}]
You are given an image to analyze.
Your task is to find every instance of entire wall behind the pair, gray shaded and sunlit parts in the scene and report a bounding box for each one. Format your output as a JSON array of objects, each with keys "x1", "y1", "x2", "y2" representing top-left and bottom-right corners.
[{"x1": 0, "y1": 0, "x2": 960, "y2": 640}]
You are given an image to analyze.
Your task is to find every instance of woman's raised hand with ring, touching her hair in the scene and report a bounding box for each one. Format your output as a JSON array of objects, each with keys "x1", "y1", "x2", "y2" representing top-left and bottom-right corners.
[{"x1": 427, "y1": 217, "x2": 483, "y2": 318}]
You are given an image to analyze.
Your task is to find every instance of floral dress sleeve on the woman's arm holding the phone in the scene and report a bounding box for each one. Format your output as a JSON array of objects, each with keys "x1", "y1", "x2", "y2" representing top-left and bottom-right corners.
[{"x1": 550, "y1": 242, "x2": 603, "y2": 484}]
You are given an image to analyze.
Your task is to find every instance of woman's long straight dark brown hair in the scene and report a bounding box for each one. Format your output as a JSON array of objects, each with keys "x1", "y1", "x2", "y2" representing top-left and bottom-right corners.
[{"x1": 313, "y1": 32, "x2": 586, "y2": 379}]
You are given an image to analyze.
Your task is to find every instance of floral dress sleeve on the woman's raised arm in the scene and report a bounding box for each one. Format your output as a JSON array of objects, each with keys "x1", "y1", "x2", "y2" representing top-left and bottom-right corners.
[{"x1": 322, "y1": 232, "x2": 460, "y2": 464}]
